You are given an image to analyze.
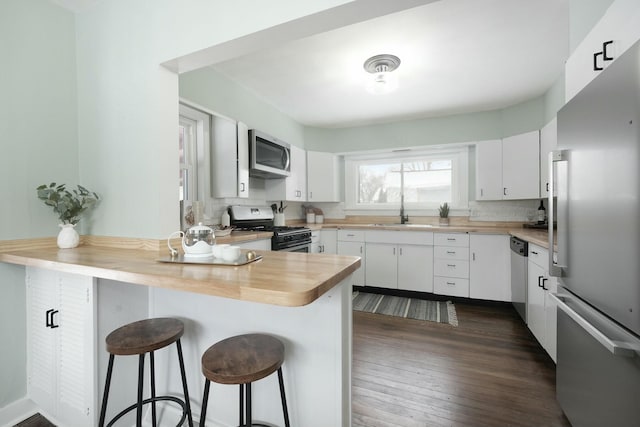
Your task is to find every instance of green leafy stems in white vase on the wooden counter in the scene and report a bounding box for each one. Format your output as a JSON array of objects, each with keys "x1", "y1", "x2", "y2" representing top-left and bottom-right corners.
[{"x1": 36, "y1": 182, "x2": 100, "y2": 249}]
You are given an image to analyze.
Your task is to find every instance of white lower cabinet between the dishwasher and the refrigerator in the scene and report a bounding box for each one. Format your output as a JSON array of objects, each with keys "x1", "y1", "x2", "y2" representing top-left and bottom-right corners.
[{"x1": 527, "y1": 244, "x2": 557, "y2": 361}]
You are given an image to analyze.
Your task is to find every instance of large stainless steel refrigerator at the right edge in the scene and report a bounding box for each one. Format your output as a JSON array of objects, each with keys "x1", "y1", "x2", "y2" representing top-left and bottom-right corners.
[{"x1": 549, "y1": 38, "x2": 640, "y2": 427}]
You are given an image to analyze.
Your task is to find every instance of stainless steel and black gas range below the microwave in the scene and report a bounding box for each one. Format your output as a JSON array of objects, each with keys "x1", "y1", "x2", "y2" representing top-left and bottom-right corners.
[{"x1": 229, "y1": 206, "x2": 311, "y2": 252}]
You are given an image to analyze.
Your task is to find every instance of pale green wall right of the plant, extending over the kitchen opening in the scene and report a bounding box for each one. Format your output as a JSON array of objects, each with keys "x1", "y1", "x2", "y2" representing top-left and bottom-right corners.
[{"x1": 76, "y1": 0, "x2": 360, "y2": 238}]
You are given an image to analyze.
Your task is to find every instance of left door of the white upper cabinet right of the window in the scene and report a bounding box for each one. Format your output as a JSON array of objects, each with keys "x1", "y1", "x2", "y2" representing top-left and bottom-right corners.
[{"x1": 476, "y1": 139, "x2": 503, "y2": 200}]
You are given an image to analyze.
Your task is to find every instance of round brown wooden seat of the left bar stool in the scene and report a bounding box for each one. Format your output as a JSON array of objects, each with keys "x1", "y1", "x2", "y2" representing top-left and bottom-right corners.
[{"x1": 105, "y1": 318, "x2": 184, "y2": 356}]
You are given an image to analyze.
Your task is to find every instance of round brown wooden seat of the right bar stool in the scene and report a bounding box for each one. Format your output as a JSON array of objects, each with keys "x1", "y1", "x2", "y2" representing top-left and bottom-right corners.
[{"x1": 202, "y1": 334, "x2": 284, "y2": 384}]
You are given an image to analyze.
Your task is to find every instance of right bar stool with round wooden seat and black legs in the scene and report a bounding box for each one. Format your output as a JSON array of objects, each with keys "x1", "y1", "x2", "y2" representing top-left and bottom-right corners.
[{"x1": 200, "y1": 334, "x2": 290, "y2": 427}]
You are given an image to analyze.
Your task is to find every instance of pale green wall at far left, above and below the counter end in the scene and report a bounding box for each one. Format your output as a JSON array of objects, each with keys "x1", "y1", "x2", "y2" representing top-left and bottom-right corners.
[{"x1": 0, "y1": 0, "x2": 78, "y2": 408}]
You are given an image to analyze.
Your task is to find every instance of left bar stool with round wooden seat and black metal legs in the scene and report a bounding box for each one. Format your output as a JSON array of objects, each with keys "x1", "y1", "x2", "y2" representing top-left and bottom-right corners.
[{"x1": 99, "y1": 318, "x2": 193, "y2": 427}]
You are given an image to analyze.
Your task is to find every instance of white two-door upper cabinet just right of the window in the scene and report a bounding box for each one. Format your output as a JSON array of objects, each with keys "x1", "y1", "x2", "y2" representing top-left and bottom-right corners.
[{"x1": 476, "y1": 131, "x2": 540, "y2": 200}]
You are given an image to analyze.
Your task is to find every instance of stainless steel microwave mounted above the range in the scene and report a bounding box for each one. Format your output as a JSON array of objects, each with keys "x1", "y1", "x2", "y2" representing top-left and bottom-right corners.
[{"x1": 249, "y1": 129, "x2": 291, "y2": 179}]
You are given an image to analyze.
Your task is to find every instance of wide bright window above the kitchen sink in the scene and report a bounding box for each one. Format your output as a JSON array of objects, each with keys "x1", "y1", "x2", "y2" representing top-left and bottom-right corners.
[{"x1": 345, "y1": 147, "x2": 468, "y2": 210}]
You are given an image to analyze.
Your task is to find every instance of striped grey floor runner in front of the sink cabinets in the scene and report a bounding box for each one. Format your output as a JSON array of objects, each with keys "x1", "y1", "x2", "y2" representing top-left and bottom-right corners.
[{"x1": 353, "y1": 291, "x2": 458, "y2": 326}]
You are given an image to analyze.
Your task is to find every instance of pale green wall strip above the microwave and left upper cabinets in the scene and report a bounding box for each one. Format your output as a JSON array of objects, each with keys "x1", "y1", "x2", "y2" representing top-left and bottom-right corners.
[{"x1": 179, "y1": 67, "x2": 304, "y2": 147}]
